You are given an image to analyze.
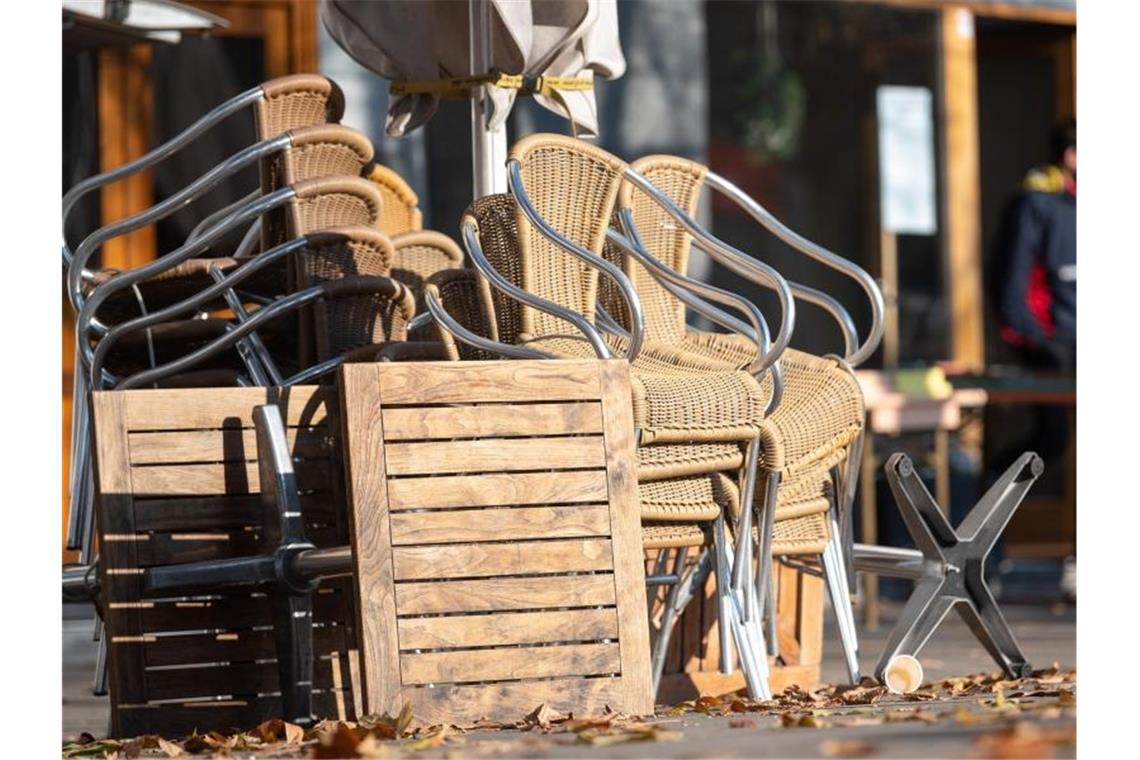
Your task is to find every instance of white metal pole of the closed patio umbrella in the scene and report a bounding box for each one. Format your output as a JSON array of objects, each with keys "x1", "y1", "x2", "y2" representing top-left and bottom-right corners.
[{"x1": 467, "y1": 0, "x2": 506, "y2": 198}]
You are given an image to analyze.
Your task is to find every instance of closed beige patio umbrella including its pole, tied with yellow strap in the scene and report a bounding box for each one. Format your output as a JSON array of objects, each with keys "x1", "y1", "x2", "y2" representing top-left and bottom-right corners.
[{"x1": 320, "y1": 0, "x2": 626, "y2": 196}]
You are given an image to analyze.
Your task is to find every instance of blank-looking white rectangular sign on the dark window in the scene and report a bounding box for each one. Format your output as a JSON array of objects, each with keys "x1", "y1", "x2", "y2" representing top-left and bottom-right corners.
[{"x1": 876, "y1": 85, "x2": 938, "y2": 235}]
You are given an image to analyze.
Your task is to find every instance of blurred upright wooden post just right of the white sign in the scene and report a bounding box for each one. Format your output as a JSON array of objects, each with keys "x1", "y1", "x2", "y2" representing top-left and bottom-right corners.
[{"x1": 938, "y1": 5, "x2": 985, "y2": 370}]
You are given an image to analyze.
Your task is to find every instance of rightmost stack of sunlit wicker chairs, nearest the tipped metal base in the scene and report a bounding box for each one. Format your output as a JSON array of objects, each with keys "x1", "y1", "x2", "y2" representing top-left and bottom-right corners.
[{"x1": 602, "y1": 151, "x2": 881, "y2": 683}]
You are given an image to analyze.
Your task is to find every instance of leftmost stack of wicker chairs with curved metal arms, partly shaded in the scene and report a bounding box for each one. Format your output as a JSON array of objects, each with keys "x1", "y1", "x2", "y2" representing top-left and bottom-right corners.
[{"x1": 64, "y1": 76, "x2": 462, "y2": 690}]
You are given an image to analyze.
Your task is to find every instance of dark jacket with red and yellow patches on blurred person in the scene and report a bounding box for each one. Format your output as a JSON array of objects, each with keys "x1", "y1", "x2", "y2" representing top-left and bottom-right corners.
[{"x1": 991, "y1": 166, "x2": 1076, "y2": 350}]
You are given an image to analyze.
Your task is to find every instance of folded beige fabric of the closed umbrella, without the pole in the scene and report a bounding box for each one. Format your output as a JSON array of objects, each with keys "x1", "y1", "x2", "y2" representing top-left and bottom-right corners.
[{"x1": 320, "y1": 0, "x2": 626, "y2": 137}]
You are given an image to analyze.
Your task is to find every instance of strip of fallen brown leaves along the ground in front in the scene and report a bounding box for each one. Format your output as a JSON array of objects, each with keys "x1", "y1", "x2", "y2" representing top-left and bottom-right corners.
[{"x1": 62, "y1": 663, "x2": 1076, "y2": 758}]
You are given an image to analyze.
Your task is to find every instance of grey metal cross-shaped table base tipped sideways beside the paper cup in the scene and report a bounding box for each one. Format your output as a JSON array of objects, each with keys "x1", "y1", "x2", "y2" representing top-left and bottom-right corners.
[{"x1": 853, "y1": 452, "x2": 1044, "y2": 680}]
